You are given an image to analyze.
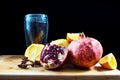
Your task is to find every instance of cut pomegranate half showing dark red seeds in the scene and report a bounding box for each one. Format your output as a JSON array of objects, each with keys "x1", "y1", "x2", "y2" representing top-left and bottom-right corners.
[{"x1": 40, "y1": 44, "x2": 68, "y2": 69}]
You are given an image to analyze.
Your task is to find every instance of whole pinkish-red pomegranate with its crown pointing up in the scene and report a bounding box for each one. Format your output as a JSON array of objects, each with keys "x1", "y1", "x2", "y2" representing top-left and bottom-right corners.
[{"x1": 68, "y1": 33, "x2": 103, "y2": 68}]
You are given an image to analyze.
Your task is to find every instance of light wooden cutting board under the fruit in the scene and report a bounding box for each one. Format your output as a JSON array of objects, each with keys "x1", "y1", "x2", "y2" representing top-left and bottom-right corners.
[{"x1": 0, "y1": 55, "x2": 120, "y2": 80}]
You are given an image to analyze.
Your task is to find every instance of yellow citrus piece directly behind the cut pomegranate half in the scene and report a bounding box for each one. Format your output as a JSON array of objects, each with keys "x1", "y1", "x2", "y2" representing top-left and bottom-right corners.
[{"x1": 50, "y1": 39, "x2": 69, "y2": 47}]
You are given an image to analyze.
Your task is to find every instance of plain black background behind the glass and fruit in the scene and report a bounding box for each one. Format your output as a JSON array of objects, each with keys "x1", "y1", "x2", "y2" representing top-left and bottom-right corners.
[{"x1": 0, "y1": 0, "x2": 120, "y2": 57}]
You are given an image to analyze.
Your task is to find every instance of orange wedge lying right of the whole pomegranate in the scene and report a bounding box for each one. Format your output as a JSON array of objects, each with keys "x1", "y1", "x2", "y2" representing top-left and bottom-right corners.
[{"x1": 99, "y1": 53, "x2": 117, "y2": 69}]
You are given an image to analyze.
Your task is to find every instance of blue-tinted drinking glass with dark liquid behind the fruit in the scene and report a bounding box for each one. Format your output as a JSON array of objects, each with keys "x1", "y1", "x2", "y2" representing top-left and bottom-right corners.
[{"x1": 24, "y1": 14, "x2": 49, "y2": 47}]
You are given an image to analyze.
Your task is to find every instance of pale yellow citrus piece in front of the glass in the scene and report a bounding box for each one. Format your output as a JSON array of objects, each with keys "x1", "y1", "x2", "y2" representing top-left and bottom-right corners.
[{"x1": 24, "y1": 43, "x2": 44, "y2": 61}]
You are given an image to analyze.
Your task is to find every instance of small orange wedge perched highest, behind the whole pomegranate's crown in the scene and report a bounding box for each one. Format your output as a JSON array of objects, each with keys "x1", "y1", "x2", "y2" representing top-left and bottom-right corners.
[{"x1": 66, "y1": 33, "x2": 81, "y2": 42}]
